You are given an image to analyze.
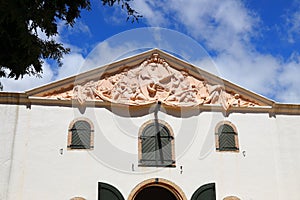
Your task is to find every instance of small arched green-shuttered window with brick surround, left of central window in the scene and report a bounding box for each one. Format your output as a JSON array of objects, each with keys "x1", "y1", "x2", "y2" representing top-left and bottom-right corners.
[{"x1": 68, "y1": 118, "x2": 94, "y2": 149}]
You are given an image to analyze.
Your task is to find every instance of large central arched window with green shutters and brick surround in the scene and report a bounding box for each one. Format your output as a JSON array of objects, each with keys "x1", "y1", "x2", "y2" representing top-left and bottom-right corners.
[{"x1": 139, "y1": 120, "x2": 175, "y2": 167}]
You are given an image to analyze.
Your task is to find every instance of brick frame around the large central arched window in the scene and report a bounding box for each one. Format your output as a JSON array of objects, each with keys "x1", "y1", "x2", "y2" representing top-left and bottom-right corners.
[{"x1": 138, "y1": 119, "x2": 176, "y2": 167}]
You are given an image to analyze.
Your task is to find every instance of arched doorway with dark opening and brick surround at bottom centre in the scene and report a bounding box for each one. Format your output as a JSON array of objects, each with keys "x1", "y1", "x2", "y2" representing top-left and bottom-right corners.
[{"x1": 128, "y1": 178, "x2": 187, "y2": 200}]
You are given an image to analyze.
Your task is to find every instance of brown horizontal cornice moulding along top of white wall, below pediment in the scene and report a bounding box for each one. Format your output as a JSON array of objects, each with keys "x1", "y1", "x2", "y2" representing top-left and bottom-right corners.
[{"x1": 0, "y1": 92, "x2": 300, "y2": 116}]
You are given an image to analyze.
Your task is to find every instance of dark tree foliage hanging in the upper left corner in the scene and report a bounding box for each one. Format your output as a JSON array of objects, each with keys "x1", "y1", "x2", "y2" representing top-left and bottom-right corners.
[{"x1": 0, "y1": 0, "x2": 141, "y2": 79}]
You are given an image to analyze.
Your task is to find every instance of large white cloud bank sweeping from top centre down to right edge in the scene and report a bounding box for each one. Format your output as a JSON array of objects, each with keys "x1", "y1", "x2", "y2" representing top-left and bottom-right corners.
[{"x1": 131, "y1": 0, "x2": 300, "y2": 102}]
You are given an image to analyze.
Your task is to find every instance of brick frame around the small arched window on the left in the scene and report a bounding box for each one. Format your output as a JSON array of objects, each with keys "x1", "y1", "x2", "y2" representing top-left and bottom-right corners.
[{"x1": 67, "y1": 117, "x2": 94, "y2": 151}]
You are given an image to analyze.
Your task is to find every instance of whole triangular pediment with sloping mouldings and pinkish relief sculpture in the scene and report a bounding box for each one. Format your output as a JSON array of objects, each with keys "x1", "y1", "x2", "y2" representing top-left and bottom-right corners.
[{"x1": 27, "y1": 49, "x2": 272, "y2": 110}]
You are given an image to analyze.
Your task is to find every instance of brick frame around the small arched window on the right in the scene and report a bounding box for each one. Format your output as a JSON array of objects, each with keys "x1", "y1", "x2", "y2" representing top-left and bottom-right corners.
[{"x1": 215, "y1": 121, "x2": 240, "y2": 153}]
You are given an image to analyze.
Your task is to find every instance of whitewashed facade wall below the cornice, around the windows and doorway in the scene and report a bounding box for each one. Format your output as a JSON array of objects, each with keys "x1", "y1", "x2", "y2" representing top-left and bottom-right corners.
[{"x1": 0, "y1": 105, "x2": 300, "y2": 200}]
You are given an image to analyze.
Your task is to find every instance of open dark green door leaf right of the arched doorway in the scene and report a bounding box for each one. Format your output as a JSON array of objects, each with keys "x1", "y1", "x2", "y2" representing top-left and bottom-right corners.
[{"x1": 191, "y1": 183, "x2": 216, "y2": 200}]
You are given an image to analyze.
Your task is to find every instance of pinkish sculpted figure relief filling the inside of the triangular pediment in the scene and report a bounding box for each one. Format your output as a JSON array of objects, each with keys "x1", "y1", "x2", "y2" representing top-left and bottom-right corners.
[{"x1": 42, "y1": 52, "x2": 262, "y2": 110}]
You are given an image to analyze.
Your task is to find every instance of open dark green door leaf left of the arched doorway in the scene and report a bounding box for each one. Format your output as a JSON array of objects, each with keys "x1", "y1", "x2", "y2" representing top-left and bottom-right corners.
[{"x1": 98, "y1": 183, "x2": 124, "y2": 200}]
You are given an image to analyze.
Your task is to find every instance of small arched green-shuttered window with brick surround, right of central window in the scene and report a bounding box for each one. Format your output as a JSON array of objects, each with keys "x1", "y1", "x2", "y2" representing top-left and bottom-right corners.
[{"x1": 216, "y1": 121, "x2": 239, "y2": 152}]
